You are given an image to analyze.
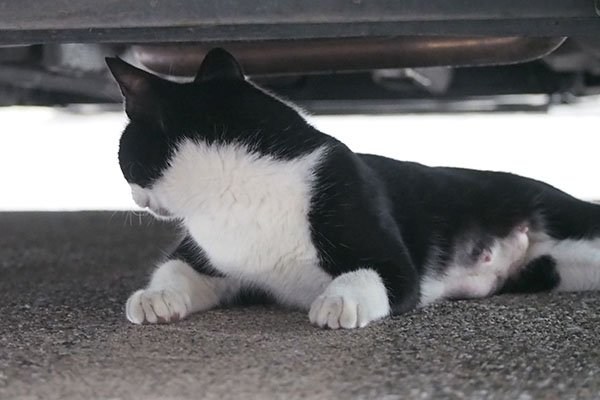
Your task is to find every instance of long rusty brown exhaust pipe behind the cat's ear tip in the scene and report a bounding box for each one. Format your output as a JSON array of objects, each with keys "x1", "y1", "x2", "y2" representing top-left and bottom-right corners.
[{"x1": 133, "y1": 36, "x2": 565, "y2": 76}]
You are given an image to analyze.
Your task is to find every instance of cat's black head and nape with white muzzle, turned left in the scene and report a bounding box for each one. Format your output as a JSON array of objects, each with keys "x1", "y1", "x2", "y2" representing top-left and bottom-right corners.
[{"x1": 106, "y1": 49, "x2": 318, "y2": 218}]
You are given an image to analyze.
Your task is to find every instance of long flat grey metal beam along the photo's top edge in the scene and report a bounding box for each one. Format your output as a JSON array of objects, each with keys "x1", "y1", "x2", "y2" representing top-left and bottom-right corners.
[{"x1": 0, "y1": 0, "x2": 600, "y2": 45}]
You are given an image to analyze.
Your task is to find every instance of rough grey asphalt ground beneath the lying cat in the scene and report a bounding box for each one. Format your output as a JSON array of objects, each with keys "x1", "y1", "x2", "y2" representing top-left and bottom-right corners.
[{"x1": 0, "y1": 213, "x2": 600, "y2": 400}]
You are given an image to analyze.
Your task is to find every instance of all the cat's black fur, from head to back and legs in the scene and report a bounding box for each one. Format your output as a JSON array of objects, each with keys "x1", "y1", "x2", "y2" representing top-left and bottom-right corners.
[{"x1": 108, "y1": 50, "x2": 600, "y2": 313}]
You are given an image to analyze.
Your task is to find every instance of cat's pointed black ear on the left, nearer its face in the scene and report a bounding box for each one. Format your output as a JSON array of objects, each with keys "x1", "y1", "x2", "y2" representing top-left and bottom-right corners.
[{"x1": 106, "y1": 57, "x2": 165, "y2": 120}]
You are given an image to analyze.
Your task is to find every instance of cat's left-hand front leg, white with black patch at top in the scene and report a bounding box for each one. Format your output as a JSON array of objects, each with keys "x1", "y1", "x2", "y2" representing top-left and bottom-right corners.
[{"x1": 125, "y1": 239, "x2": 240, "y2": 324}]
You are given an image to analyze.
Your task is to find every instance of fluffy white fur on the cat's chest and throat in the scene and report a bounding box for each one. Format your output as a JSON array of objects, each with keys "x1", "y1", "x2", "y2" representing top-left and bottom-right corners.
[{"x1": 155, "y1": 141, "x2": 331, "y2": 306}]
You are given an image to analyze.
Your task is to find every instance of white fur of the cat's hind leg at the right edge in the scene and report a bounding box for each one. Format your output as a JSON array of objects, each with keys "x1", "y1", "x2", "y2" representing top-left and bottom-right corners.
[{"x1": 527, "y1": 234, "x2": 600, "y2": 291}]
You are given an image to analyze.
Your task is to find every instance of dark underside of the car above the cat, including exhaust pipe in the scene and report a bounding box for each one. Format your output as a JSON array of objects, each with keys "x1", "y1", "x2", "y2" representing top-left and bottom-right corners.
[{"x1": 0, "y1": 0, "x2": 600, "y2": 114}]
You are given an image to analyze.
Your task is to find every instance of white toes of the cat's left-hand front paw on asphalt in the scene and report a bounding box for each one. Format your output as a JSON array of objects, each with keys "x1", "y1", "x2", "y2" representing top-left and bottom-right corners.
[{"x1": 125, "y1": 289, "x2": 188, "y2": 324}]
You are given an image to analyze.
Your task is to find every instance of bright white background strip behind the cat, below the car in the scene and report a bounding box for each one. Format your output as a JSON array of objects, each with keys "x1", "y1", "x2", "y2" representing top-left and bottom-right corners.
[{"x1": 0, "y1": 99, "x2": 600, "y2": 211}]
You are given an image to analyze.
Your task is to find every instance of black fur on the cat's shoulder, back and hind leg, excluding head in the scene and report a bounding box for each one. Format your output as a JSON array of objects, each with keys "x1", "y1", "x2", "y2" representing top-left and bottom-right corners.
[{"x1": 311, "y1": 145, "x2": 600, "y2": 311}]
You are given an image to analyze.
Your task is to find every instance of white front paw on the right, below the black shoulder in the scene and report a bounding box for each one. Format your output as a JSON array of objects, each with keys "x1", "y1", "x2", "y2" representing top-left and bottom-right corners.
[{"x1": 308, "y1": 269, "x2": 390, "y2": 329}]
